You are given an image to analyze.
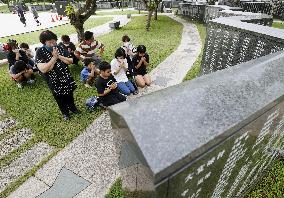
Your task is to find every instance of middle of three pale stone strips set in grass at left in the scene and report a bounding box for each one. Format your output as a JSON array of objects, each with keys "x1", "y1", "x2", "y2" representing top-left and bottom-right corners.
[{"x1": 0, "y1": 128, "x2": 32, "y2": 159}]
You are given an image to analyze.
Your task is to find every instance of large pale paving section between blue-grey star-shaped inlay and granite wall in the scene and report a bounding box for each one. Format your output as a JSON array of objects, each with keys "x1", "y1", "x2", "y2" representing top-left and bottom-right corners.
[{"x1": 36, "y1": 112, "x2": 119, "y2": 197}]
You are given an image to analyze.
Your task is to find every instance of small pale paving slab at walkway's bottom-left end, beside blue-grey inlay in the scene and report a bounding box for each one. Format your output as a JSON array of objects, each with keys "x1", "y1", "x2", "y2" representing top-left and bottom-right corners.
[{"x1": 8, "y1": 177, "x2": 50, "y2": 198}]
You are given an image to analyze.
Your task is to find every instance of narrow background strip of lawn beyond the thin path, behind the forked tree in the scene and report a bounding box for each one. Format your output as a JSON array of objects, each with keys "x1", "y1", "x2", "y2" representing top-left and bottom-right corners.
[{"x1": 0, "y1": 17, "x2": 113, "y2": 45}]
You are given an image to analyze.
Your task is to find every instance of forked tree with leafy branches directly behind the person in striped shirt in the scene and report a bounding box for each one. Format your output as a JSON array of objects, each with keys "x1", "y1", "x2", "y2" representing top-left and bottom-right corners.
[{"x1": 65, "y1": 0, "x2": 97, "y2": 42}]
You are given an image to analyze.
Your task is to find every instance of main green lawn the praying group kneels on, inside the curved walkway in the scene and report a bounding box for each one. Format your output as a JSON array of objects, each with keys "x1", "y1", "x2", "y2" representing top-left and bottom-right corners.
[{"x1": 0, "y1": 16, "x2": 182, "y2": 197}]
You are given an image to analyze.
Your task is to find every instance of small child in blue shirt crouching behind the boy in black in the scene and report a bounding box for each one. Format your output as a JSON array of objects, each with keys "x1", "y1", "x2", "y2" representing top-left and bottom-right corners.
[{"x1": 80, "y1": 58, "x2": 100, "y2": 88}]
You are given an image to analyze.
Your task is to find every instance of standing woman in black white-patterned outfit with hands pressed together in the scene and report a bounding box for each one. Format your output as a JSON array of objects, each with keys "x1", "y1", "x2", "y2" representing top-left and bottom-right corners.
[{"x1": 36, "y1": 30, "x2": 80, "y2": 120}]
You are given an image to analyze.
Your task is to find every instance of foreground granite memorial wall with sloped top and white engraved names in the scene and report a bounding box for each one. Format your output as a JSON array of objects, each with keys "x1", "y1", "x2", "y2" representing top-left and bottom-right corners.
[{"x1": 110, "y1": 51, "x2": 284, "y2": 198}]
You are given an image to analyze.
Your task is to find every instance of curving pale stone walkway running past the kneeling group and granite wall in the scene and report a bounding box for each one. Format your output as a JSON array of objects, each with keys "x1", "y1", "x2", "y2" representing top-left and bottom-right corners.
[{"x1": 9, "y1": 14, "x2": 201, "y2": 198}]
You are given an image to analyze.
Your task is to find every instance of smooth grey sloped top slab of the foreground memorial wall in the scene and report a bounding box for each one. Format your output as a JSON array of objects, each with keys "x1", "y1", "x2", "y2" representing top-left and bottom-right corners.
[{"x1": 110, "y1": 50, "x2": 284, "y2": 186}]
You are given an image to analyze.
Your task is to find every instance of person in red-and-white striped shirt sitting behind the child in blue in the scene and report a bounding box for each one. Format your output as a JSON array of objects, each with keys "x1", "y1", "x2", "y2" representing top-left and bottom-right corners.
[{"x1": 75, "y1": 31, "x2": 104, "y2": 65}]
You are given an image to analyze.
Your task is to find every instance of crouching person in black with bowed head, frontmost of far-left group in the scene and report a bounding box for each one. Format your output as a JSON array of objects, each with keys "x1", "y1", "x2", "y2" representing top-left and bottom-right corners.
[{"x1": 10, "y1": 60, "x2": 34, "y2": 89}]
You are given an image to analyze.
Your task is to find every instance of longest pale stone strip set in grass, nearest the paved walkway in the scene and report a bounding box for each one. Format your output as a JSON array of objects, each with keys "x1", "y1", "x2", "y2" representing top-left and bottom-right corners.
[{"x1": 0, "y1": 142, "x2": 53, "y2": 193}]
